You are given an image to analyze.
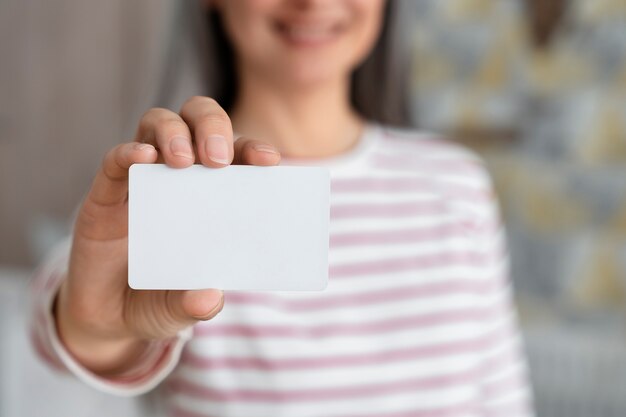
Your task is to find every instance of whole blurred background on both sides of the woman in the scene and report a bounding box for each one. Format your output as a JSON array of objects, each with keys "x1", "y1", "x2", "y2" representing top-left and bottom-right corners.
[{"x1": 0, "y1": 0, "x2": 626, "y2": 417}]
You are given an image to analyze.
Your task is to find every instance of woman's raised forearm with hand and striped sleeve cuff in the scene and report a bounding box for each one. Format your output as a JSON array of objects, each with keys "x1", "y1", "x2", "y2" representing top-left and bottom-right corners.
[{"x1": 33, "y1": 97, "x2": 280, "y2": 395}]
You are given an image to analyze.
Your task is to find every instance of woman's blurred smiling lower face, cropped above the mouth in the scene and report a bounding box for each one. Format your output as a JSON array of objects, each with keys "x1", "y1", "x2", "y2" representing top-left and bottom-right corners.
[{"x1": 215, "y1": 0, "x2": 385, "y2": 87}]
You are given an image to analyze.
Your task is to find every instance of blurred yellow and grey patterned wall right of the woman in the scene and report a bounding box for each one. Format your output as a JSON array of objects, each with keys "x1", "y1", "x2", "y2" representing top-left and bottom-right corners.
[{"x1": 414, "y1": 0, "x2": 626, "y2": 417}]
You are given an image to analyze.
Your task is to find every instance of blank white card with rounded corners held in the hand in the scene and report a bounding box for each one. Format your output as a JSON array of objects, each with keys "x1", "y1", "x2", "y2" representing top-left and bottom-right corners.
[{"x1": 128, "y1": 164, "x2": 330, "y2": 291}]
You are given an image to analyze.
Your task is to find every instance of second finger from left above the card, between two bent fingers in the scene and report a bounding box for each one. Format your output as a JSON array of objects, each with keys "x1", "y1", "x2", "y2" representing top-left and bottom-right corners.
[{"x1": 136, "y1": 108, "x2": 195, "y2": 168}]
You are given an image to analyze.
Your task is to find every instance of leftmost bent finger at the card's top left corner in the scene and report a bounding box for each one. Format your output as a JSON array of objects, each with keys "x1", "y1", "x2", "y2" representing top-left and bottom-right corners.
[{"x1": 88, "y1": 142, "x2": 157, "y2": 206}]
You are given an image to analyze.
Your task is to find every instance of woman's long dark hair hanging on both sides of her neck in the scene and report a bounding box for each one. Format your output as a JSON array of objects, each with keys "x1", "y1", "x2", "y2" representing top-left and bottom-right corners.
[{"x1": 156, "y1": 0, "x2": 411, "y2": 126}]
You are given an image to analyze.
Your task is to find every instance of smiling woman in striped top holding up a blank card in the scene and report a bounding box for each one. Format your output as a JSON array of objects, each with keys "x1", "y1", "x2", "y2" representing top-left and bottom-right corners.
[{"x1": 34, "y1": 0, "x2": 529, "y2": 416}]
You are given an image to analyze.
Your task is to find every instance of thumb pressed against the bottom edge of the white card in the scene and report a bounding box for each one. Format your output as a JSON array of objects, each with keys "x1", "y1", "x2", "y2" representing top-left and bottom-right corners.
[{"x1": 126, "y1": 289, "x2": 224, "y2": 339}]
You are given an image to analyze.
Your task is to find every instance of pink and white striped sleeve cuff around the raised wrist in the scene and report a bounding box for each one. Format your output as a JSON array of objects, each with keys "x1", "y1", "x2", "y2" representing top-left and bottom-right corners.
[{"x1": 30, "y1": 238, "x2": 192, "y2": 396}]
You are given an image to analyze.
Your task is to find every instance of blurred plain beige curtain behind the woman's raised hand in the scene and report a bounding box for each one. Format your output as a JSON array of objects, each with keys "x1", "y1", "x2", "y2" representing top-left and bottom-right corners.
[{"x1": 0, "y1": 0, "x2": 175, "y2": 265}]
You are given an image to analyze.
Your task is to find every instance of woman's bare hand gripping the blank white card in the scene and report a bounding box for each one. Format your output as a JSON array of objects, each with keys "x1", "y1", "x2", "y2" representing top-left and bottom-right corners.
[{"x1": 55, "y1": 97, "x2": 280, "y2": 375}]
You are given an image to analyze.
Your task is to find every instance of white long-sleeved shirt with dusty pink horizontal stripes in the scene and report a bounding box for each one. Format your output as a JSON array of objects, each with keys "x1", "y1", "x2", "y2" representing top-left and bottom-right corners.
[{"x1": 33, "y1": 125, "x2": 532, "y2": 417}]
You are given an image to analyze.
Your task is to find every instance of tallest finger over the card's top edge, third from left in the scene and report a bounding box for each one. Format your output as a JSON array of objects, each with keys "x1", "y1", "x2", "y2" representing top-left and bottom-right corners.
[{"x1": 180, "y1": 96, "x2": 233, "y2": 167}]
